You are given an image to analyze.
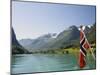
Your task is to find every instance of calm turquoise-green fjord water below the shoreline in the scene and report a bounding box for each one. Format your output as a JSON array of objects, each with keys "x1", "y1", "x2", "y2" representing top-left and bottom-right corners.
[{"x1": 11, "y1": 54, "x2": 96, "y2": 74}]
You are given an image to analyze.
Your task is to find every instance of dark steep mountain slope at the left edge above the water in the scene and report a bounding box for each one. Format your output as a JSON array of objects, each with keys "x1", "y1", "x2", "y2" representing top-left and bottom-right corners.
[{"x1": 11, "y1": 28, "x2": 29, "y2": 54}]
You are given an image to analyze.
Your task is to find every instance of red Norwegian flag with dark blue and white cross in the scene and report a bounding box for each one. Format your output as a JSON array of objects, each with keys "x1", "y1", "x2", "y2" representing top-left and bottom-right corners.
[{"x1": 79, "y1": 28, "x2": 90, "y2": 68}]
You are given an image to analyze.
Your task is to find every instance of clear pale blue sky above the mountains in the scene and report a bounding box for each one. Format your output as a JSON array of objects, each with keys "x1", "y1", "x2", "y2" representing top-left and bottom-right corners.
[{"x1": 12, "y1": 1, "x2": 96, "y2": 40}]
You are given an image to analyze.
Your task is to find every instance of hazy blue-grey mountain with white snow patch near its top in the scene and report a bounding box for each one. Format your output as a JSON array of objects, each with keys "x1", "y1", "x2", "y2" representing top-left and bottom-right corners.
[{"x1": 24, "y1": 33, "x2": 56, "y2": 50}]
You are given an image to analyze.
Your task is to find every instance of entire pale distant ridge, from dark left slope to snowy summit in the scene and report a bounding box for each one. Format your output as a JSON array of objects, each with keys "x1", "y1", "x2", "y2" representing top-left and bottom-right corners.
[{"x1": 19, "y1": 33, "x2": 57, "y2": 50}]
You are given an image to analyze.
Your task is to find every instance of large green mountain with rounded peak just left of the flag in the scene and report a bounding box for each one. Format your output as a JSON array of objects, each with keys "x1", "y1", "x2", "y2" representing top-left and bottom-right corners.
[{"x1": 39, "y1": 25, "x2": 79, "y2": 49}]
